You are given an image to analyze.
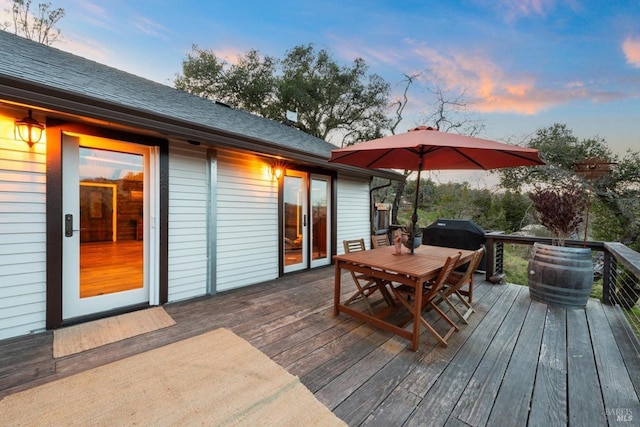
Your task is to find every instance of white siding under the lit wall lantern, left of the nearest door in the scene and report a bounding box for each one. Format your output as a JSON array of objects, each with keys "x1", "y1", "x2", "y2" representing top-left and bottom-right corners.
[{"x1": 0, "y1": 116, "x2": 46, "y2": 340}]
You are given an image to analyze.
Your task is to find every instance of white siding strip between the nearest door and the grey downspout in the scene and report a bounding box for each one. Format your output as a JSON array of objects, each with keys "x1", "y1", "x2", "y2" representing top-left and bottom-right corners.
[{"x1": 169, "y1": 142, "x2": 209, "y2": 301}]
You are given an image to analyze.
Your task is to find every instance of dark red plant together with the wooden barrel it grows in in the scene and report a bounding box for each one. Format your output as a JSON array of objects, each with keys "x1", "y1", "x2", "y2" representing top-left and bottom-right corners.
[{"x1": 528, "y1": 181, "x2": 593, "y2": 308}]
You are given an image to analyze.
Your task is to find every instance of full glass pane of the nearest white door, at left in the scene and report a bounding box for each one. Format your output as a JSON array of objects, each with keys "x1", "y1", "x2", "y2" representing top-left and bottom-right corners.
[{"x1": 79, "y1": 147, "x2": 144, "y2": 298}]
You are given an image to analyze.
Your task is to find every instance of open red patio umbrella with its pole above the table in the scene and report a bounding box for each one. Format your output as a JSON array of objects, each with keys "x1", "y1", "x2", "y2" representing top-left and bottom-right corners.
[{"x1": 329, "y1": 126, "x2": 544, "y2": 253}]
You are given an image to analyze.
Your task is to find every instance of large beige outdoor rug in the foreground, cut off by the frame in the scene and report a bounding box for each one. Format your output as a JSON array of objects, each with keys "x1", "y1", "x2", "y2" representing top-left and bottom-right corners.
[{"x1": 0, "y1": 329, "x2": 346, "y2": 427}]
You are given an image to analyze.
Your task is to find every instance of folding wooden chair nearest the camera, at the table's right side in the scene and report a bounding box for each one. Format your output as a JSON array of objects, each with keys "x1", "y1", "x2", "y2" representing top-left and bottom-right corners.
[{"x1": 392, "y1": 252, "x2": 462, "y2": 347}]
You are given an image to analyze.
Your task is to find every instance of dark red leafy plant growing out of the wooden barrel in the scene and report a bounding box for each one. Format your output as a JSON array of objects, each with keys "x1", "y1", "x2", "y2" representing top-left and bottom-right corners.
[{"x1": 529, "y1": 182, "x2": 587, "y2": 246}]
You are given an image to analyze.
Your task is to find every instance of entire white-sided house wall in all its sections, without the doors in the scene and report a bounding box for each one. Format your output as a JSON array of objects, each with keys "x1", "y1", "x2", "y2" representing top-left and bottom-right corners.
[{"x1": 0, "y1": 111, "x2": 370, "y2": 339}]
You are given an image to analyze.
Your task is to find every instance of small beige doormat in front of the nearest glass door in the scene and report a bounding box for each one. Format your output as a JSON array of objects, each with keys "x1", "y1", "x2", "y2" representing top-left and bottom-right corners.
[{"x1": 53, "y1": 307, "x2": 176, "y2": 358}]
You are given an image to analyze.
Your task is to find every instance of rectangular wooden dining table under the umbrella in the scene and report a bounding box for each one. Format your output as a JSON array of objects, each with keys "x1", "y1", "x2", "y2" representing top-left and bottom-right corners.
[{"x1": 333, "y1": 245, "x2": 474, "y2": 351}]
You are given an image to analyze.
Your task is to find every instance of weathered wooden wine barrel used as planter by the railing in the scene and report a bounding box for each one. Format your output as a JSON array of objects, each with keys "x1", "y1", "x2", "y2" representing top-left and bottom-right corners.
[{"x1": 529, "y1": 243, "x2": 593, "y2": 308}]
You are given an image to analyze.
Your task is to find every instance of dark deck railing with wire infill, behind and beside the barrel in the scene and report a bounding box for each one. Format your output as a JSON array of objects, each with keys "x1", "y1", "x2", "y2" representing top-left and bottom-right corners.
[{"x1": 485, "y1": 232, "x2": 640, "y2": 337}]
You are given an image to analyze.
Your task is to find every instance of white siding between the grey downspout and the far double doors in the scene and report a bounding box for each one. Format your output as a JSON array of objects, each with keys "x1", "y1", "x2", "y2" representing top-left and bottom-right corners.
[{"x1": 216, "y1": 151, "x2": 279, "y2": 291}]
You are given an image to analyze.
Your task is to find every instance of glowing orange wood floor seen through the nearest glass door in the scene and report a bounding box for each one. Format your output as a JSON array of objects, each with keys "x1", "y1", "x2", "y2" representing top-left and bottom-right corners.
[{"x1": 80, "y1": 240, "x2": 144, "y2": 298}]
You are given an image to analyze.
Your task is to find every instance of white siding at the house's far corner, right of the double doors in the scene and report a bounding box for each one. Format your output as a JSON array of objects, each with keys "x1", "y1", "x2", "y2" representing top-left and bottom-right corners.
[{"x1": 336, "y1": 175, "x2": 371, "y2": 254}]
